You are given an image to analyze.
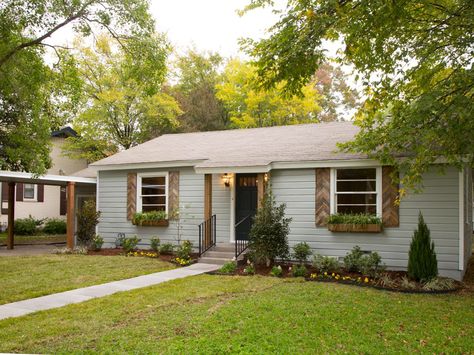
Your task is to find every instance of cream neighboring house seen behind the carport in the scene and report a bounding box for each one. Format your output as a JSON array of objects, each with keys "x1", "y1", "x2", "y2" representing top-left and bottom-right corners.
[{"x1": 0, "y1": 127, "x2": 87, "y2": 225}]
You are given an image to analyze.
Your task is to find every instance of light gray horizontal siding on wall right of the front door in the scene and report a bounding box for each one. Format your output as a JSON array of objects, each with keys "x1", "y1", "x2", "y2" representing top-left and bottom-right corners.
[{"x1": 271, "y1": 168, "x2": 460, "y2": 278}]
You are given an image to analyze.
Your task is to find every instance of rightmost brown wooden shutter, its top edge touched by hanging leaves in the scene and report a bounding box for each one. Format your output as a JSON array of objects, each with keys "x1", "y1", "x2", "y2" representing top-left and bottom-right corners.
[{"x1": 382, "y1": 166, "x2": 400, "y2": 227}]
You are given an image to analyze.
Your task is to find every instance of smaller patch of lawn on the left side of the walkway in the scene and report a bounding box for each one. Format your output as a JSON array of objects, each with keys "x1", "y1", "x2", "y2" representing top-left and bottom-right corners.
[{"x1": 0, "y1": 255, "x2": 173, "y2": 304}]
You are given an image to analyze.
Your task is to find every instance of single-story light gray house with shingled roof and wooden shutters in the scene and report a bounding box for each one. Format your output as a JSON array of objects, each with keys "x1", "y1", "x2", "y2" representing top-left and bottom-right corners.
[{"x1": 91, "y1": 122, "x2": 472, "y2": 280}]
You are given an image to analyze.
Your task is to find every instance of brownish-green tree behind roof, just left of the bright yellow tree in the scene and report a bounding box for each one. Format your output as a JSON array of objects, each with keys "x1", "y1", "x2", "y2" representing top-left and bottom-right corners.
[{"x1": 171, "y1": 49, "x2": 228, "y2": 132}]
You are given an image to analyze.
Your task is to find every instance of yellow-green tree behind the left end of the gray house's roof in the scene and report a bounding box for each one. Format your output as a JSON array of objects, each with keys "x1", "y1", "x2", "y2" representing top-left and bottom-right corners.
[{"x1": 65, "y1": 36, "x2": 181, "y2": 161}]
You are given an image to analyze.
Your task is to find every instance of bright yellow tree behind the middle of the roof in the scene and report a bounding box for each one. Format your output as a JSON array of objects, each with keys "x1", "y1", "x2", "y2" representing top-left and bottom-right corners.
[{"x1": 216, "y1": 59, "x2": 321, "y2": 128}]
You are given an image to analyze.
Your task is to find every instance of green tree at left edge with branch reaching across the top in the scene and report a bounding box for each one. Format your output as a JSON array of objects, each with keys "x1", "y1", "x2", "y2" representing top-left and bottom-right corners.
[{"x1": 0, "y1": 0, "x2": 153, "y2": 174}]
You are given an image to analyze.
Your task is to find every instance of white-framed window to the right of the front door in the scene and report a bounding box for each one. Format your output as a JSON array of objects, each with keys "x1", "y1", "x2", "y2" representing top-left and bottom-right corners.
[{"x1": 331, "y1": 168, "x2": 382, "y2": 216}]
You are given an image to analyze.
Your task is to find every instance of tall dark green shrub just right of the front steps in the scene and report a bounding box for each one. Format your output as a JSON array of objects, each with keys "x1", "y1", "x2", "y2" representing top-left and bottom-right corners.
[{"x1": 249, "y1": 191, "x2": 291, "y2": 266}]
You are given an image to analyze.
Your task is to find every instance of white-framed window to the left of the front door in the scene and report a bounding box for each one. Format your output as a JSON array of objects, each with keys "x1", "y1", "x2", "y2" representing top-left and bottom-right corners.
[{"x1": 137, "y1": 173, "x2": 168, "y2": 212}]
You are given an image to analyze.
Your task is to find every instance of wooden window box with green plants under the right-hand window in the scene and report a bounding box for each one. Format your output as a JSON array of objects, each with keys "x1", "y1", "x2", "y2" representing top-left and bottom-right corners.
[{"x1": 327, "y1": 213, "x2": 382, "y2": 233}]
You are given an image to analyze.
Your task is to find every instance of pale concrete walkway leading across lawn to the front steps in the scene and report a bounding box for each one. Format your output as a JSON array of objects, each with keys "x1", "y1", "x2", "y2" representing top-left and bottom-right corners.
[{"x1": 0, "y1": 263, "x2": 220, "y2": 319}]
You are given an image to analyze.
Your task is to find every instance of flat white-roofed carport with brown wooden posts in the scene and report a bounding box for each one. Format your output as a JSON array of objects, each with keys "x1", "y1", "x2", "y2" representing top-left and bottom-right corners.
[{"x1": 0, "y1": 171, "x2": 96, "y2": 249}]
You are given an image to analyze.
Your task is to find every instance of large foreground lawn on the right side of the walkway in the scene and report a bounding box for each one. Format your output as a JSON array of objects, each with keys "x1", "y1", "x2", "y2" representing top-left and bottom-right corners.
[{"x1": 0, "y1": 275, "x2": 474, "y2": 354}]
